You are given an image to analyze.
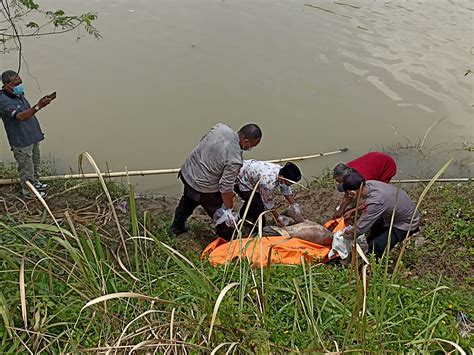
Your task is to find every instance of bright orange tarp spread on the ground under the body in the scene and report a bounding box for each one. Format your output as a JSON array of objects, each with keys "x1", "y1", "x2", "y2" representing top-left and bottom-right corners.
[{"x1": 202, "y1": 220, "x2": 344, "y2": 266}]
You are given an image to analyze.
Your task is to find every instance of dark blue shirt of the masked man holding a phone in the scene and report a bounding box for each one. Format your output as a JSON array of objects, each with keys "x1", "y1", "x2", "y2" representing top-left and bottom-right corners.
[{"x1": 0, "y1": 90, "x2": 44, "y2": 148}]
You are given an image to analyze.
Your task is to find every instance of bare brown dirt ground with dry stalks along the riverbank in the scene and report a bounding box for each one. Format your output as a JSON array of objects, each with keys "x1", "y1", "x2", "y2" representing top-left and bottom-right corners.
[{"x1": 0, "y1": 181, "x2": 474, "y2": 290}]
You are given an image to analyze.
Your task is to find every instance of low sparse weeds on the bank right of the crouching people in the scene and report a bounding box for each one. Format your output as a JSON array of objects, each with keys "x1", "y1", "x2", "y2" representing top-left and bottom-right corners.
[{"x1": 405, "y1": 183, "x2": 474, "y2": 288}]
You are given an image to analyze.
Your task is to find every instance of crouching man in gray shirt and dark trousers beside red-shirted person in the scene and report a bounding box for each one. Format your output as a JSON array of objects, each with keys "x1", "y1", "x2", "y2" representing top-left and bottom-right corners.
[{"x1": 342, "y1": 173, "x2": 420, "y2": 258}]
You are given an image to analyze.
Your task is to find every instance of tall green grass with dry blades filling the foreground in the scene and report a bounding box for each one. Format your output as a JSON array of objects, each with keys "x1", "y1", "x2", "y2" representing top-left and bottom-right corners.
[{"x1": 0, "y1": 157, "x2": 467, "y2": 354}]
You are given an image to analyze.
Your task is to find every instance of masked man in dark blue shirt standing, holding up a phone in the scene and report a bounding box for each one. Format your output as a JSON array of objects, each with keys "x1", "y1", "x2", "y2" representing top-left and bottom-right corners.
[{"x1": 0, "y1": 70, "x2": 54, "y2": 198}]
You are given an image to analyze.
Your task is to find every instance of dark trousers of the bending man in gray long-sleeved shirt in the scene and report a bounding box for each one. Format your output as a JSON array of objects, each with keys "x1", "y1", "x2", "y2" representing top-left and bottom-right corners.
[{"x1": 173, "y1": 175, "x2": 234, "y2": 240}]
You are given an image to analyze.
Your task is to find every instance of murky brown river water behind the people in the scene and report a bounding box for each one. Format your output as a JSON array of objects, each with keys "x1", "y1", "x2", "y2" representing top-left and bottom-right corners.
[{"x1": 0, "y1": 0, "x2": 474, "y2": 194}]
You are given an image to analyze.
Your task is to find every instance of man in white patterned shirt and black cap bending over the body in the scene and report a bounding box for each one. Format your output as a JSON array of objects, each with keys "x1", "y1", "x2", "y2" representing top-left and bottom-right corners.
[{"x1": 235, "y1": 159, "x2": 303, "y2": 227}]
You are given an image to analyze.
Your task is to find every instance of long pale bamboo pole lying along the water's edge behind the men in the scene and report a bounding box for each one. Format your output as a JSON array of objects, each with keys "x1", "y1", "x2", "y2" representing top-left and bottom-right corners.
[{"x1": 0, "y1": 148, "x2": 348, "y2": 185}]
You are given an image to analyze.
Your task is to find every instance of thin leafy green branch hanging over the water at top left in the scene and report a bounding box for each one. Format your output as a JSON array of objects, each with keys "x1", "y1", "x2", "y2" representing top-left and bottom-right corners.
[{"x1": 0, "y1": 0, "x2": 101, "y2": 45}]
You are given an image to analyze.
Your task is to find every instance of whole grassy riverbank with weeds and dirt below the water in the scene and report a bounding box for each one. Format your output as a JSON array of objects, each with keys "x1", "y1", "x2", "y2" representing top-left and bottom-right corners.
[{"x1": 0, "y1": 156, "x2": 474, "y2": 353}]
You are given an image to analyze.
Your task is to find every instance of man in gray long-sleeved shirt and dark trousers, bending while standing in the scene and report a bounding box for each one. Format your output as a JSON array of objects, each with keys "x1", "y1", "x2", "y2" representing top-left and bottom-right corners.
[{"x1": 169, "y1": 123, "x2": 262, "y2": 239}]
